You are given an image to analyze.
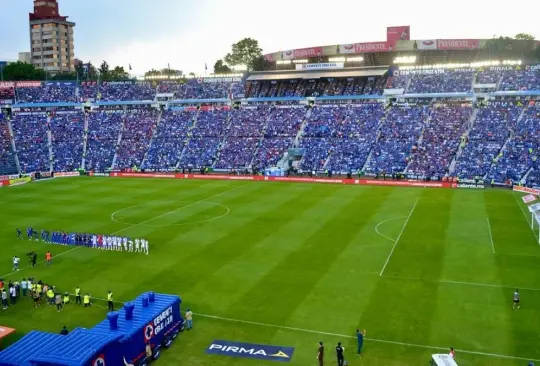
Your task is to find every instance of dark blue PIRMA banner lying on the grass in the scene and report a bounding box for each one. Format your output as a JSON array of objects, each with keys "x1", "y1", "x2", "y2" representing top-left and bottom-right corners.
[{"x1": 206, "y1": 340, "x2": 294, "y2": 362}]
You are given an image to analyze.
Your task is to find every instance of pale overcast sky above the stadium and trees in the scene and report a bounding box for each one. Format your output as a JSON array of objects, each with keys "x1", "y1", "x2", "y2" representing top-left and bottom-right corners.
[{"x1": 0, "y1": 0, "x2": 540, "y2": 75}]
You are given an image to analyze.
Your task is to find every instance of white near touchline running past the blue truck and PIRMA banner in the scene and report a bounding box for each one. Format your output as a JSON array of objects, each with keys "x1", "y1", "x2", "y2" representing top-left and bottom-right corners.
[{"x1": 70, "y1": 294, "x2": 540, "y2": 362}]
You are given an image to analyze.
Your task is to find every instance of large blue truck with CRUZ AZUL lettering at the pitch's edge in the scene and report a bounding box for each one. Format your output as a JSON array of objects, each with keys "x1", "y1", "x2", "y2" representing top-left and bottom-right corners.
[{"x1": 0, "y1": 292, "x2": 184, "y2": 366}]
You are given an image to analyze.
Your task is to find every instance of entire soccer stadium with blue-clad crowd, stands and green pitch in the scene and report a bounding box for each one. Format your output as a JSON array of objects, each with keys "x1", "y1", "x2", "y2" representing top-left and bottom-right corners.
[{"x1": 0, "y1": 0, "x2": 540, "y2": 366}]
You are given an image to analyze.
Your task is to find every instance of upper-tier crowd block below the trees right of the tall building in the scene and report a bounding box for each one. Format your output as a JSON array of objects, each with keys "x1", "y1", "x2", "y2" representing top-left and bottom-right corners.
[{"x1": 97, "y1": 81, "x2": 156, "y2": 102}]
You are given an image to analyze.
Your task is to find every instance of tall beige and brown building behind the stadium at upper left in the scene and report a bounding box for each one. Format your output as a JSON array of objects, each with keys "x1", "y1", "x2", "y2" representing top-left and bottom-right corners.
[{"x1": 30, "y1": 0, "x2": 75, "y2": 74}]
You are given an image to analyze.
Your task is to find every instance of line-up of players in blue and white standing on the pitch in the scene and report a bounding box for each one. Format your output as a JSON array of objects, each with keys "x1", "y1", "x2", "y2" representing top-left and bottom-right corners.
[{"x1": 17, "y1": 227, "x2": 149, "y2": 254}]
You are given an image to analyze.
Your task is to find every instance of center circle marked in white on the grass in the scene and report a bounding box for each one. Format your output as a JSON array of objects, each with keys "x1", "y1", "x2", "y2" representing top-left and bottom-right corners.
[{"x1": 111, "y1": 201, "x2": 231, "y2": 227}]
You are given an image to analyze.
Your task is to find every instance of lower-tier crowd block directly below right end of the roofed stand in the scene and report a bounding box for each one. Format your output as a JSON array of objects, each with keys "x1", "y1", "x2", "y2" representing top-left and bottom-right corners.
[{"x1": 327, "y1": 103, "x2": 385, "y2": 172}]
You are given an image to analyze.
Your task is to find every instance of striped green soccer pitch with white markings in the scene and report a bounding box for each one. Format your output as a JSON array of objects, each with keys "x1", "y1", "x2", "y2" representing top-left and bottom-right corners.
[{"x1": 0, "y1": 177, "x2": 540, "y2": 366}]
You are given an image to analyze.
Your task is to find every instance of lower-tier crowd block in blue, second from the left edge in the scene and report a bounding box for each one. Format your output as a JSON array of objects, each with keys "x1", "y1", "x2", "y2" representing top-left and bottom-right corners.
[{"x1": 12, "y1": 113, "x2": 50, "y2": 173}]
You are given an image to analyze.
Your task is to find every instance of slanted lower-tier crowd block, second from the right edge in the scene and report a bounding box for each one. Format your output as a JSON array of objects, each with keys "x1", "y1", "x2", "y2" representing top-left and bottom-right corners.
[{"x1": 453, "y1": 103, "x2": 523, "y2": 179}]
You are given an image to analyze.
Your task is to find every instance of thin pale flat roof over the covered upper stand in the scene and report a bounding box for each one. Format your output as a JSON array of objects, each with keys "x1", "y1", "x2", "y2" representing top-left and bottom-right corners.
[{"x1": 247, "y1": 66, "x2": 388, "y2": 81}]
